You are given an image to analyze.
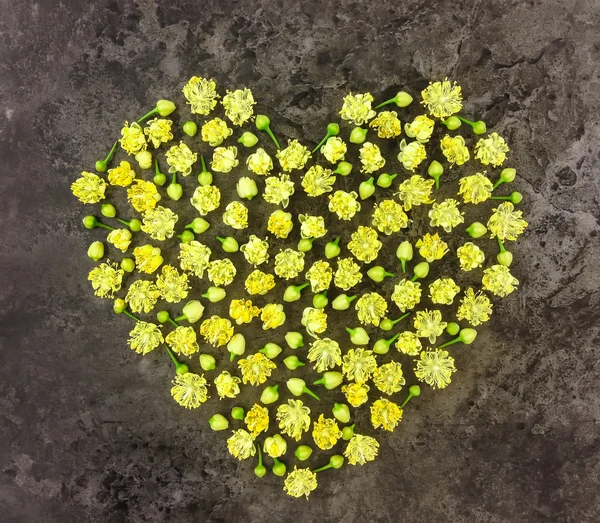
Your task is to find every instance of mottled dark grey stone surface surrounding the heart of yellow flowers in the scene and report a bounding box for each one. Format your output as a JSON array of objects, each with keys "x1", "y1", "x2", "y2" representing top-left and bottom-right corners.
[{"x1": 0, "y1": 0, "x2": 600, "y2": 523}]
